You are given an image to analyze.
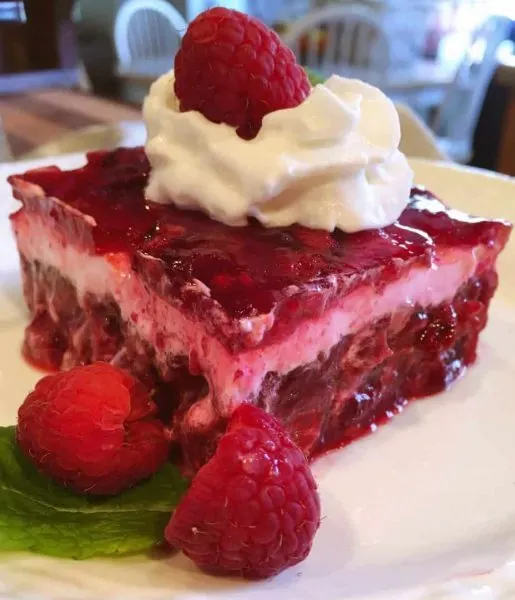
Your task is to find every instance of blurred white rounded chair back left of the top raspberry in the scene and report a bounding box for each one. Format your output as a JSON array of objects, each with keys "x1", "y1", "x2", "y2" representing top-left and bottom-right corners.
[{"x1": 114, "y1": 0, "x2": 187, "y2": 80}]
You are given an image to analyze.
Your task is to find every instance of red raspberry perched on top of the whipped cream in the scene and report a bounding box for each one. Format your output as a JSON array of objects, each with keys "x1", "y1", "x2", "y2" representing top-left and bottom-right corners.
[{"x1": 175, "y1": 7, "x2": 310, "y2": 139}]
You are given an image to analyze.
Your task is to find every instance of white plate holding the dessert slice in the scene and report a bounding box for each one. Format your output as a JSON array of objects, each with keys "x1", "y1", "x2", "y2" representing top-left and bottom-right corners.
[{"x1": 0, "y1": 156, "x2": 515, "y2": 600}]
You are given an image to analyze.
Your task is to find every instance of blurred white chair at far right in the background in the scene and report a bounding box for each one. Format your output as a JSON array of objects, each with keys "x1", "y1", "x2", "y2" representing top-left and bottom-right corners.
[{"x1": 433, "y1": 17, "x2": 511, "y2": 163}]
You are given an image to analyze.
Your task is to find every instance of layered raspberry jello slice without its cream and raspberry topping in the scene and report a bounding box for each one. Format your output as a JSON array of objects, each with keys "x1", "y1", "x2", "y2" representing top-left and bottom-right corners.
[{"x1": 10, "y1": 149, "x2": 510, "y2": 468}]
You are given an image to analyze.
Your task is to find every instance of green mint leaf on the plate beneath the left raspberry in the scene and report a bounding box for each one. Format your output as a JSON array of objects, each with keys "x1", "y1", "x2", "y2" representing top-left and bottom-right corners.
[{"x1": 0, "y1": 427, "x2": 187, "y2": 559}]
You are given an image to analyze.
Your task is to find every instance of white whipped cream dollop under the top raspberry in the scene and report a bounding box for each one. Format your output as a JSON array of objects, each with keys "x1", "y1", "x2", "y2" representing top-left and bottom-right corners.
[{"x1": 143, "y1": 72, "x2": 413, "y2": 233}]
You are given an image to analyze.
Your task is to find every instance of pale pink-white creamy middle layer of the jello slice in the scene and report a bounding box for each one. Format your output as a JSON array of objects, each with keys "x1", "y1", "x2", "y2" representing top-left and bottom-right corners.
[{"x1": 18, "y1": 216, "x2": 485, "y2": 428}]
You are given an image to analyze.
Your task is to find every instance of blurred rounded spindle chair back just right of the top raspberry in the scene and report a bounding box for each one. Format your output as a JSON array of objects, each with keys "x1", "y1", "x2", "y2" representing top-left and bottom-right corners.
[{"x1": 283, "y1": 4, "x2": 390, "y2": 82}]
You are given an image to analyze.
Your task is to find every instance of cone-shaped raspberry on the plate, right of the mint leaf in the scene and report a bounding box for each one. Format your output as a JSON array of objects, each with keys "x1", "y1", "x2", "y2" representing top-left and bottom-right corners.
[{"x1": 165, "y1": 404, "x2": 320, "y2": 579}]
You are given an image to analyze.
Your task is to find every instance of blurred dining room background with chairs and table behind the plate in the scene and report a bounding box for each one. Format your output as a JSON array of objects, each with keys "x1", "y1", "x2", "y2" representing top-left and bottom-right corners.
[{"x1": 0, "y1": 0, "x2": 515, "y2": 176}]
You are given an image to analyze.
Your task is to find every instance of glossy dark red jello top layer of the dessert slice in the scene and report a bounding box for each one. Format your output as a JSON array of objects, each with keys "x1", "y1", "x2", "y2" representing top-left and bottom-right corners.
[{"x1": 10, "y1": 148, "x2": 509, "y2": 346}]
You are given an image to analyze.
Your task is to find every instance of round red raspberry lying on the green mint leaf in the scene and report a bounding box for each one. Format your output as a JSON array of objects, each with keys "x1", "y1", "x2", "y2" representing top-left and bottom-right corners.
[{"x1": 17, "y1": 363, "x2": 169, "y2": 495}]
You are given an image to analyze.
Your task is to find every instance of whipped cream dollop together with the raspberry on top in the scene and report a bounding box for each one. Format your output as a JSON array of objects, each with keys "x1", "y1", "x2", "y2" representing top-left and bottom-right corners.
[{"x1": 143, "y1": 8, "x2": 413, "y2": 233}]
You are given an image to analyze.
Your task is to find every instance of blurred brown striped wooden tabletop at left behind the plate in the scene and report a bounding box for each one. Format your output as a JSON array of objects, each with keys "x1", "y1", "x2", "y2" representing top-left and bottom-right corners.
[{"x1": 0, "y1": 90, "x2": 141, "y2": 158}]
